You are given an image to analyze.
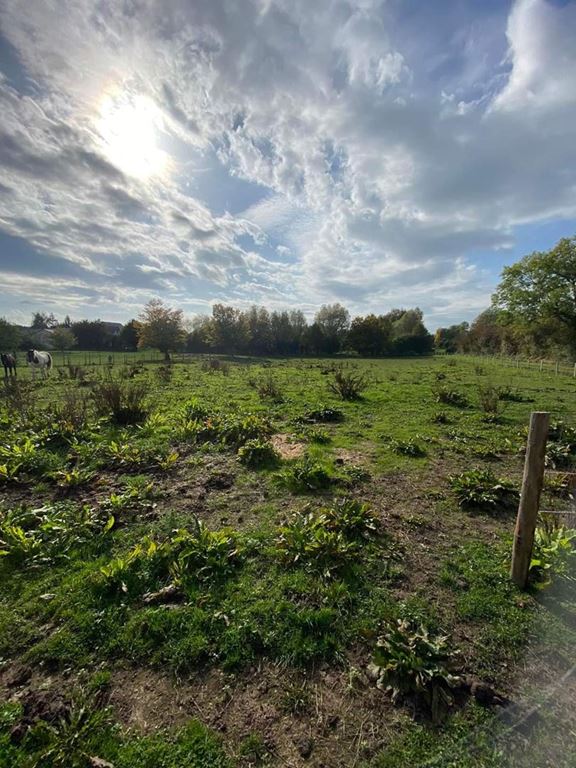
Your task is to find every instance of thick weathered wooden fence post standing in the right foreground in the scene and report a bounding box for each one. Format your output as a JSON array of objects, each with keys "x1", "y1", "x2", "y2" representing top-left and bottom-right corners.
[{"x1": 510, "y1": 411, "x2": 550, "y2": 589}]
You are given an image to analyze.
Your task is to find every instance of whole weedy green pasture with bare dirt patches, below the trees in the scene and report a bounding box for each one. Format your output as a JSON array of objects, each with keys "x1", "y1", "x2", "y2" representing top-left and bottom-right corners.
[{"x1": 0, "y1": 353, "x2": 576, "y2": 768}]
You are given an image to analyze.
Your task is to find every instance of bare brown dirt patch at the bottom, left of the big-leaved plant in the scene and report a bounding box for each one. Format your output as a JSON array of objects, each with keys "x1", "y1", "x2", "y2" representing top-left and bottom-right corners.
[{"x1": 110, "y1": 664, "x2": 402, "y2": 768}]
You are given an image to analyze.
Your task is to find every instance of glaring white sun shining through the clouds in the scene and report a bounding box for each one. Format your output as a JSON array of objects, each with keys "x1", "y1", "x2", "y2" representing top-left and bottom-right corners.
[{"x1": 96, "y1": 90, "x2": 169, "y2": 179}]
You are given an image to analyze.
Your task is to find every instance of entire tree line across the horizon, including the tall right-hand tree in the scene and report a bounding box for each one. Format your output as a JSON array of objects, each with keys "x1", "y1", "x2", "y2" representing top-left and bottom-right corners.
[{"x1": 0, "y1": 236, "x2": 576, "y2": 359}]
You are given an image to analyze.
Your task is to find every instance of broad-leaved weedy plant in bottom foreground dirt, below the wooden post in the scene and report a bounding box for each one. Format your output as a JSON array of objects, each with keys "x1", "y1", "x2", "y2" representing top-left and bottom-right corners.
[{"x1": 373, "y1": 619, "x2": 460, "y2": 722}]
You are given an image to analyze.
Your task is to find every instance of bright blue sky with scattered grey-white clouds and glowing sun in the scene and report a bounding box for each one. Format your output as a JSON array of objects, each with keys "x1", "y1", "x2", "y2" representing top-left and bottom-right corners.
[{"x1": 0, "y1": 0, "x2": 576, "y2": 330}]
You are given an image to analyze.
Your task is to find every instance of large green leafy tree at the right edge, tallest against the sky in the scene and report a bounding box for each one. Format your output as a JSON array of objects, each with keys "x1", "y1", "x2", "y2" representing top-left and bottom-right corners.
[{"x1": 493, "y1": 236, "x2": 576, "y2": 355}]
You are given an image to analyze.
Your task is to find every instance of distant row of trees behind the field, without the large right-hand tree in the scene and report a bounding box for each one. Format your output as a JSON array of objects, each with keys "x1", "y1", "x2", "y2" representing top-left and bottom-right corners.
[{"x1": 0, "y1": 299, "x2": 433, "y2": 357}]
